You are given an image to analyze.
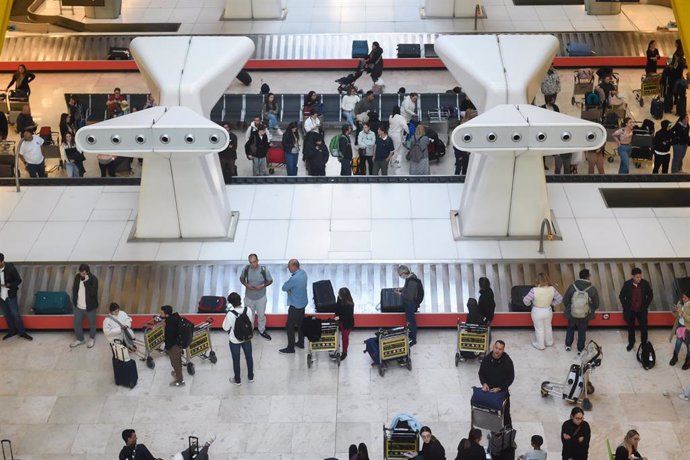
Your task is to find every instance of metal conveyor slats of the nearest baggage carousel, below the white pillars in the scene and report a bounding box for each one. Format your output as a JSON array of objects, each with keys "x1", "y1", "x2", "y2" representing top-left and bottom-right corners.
[{"x1": 15, "y1": 258, "x2": 690, "y2": 314}]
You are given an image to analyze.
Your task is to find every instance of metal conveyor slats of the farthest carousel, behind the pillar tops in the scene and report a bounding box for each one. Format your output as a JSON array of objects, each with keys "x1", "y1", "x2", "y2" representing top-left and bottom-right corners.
[{"x1": 0, "y1": 32, "x2": 678, "y2": 62}]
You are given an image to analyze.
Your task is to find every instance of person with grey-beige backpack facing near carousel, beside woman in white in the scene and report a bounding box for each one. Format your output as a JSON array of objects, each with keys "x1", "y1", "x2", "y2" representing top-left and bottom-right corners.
[{"x1": 563, "y1": 268, "x2": 599, "y2": 355}]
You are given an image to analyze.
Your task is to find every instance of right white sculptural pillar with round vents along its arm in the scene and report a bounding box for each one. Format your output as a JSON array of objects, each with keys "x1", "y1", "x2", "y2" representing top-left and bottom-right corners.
[{"x1": 435, "y1": 35, "x2": 606, "y2": 238}]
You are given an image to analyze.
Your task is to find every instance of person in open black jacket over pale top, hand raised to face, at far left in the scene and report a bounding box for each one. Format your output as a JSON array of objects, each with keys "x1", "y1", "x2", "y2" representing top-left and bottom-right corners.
[{"x1": 70, "y1": 264, "x2": 98, "y2": 348}]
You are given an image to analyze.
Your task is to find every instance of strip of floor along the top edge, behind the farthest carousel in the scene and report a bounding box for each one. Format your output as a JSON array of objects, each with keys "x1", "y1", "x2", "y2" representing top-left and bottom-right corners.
[{"x1": 30, "y1": 0, "x2": 673, "y2": 35}]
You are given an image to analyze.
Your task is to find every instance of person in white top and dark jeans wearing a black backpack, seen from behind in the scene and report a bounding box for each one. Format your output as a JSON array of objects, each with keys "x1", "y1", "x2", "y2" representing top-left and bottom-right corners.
[{"x1": 223, "y1": 292, "x2": 254, "y2": 386}]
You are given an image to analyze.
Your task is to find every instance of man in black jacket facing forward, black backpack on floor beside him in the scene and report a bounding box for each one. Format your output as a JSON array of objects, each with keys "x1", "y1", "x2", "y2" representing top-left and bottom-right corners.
[{"x1": 618, "y1": 267, "x2": 654, "y2": 351}]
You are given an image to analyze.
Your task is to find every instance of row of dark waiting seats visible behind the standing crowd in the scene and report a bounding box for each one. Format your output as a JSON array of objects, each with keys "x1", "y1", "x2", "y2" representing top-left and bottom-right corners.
[{"x1": 65, "y1": 92, "x2": 464, "y2": 128}]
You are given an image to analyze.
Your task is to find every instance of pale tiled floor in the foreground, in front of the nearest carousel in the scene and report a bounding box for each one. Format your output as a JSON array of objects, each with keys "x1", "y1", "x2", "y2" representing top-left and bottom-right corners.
[{"x1": 0, "y1": 330, "x2": 690, "y2": 460}]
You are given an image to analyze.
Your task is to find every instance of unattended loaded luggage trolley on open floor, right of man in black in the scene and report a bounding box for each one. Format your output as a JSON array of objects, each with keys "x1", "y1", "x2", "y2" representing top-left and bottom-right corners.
[{"x1": 541, "y1": 340, "x2": 603, "y2": 411}]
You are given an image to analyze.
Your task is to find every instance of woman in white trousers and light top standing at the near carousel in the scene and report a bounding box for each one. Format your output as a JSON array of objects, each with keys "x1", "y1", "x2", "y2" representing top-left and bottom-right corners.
[{"x1": 522, "y1": 273, "x2": 563, "y2": 350}]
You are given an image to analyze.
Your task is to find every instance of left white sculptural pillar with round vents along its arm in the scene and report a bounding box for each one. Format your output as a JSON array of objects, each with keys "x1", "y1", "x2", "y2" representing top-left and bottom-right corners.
[{"x1": 76, "y1": 36, "x2": 254, "y2": 239}]
